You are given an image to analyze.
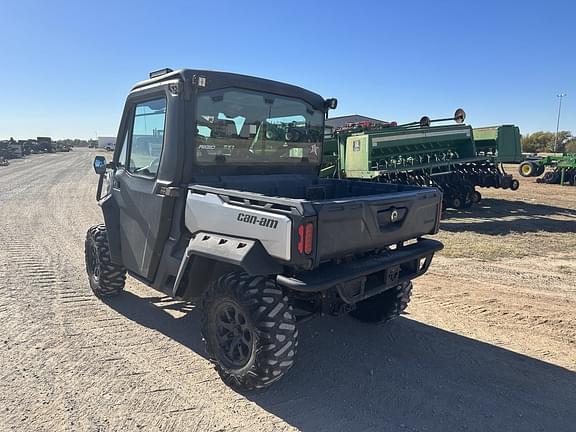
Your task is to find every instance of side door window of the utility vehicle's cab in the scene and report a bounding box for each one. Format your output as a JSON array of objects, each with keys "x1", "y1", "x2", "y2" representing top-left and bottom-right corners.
[{"x1": 128, "y1": 98, "x2": 166, "y2": 177}]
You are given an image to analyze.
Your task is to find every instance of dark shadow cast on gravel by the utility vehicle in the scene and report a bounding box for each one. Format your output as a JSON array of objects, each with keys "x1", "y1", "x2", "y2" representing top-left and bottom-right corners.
[{"x1": 107, "y1": 292, "x2": 576, "y2": 431}]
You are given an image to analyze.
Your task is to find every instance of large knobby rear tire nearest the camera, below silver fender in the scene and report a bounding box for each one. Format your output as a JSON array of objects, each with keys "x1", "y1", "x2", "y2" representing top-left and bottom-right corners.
[{"x1": 202, "y1": 272, "x2": 298, "y2": 390}]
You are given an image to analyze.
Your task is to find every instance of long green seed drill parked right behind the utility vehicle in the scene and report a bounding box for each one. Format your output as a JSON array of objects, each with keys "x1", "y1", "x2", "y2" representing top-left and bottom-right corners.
[{"x1": 322, "y1": 109, "x2": 521, "y2": 209}]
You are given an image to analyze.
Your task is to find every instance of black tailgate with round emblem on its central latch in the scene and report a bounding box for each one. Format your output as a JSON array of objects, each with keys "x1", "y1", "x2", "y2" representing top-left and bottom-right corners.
[{"x1": 313, "y1": 188, "x2": 442, "y2": 261}]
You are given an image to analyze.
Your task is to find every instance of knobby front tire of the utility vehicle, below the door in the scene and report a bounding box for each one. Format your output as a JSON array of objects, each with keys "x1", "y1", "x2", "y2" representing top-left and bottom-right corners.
[{"x1": 84, "y1": 224, "x2": 126, "y2": 297}]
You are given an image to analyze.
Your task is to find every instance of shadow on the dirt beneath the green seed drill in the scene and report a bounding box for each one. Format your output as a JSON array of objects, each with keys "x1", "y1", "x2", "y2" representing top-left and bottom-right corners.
[{"x1": 441, "y1": 199, "x2": 576, "y2": 235}]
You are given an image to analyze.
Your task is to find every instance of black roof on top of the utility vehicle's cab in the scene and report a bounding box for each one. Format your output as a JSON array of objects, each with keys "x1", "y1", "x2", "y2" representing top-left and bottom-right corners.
[{"x1": 132, "y1": 69, "x2": 324, "y2": 110}]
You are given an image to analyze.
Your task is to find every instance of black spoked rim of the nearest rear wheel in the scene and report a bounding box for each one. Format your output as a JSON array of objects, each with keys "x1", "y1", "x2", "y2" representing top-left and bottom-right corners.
[{"x1": 215, "y1": 301, "x2": 254, "y2": 369}]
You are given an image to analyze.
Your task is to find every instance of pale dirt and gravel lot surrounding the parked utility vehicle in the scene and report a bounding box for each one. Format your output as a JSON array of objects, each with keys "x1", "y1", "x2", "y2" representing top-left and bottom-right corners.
[{"x1": 0, "y1": 149, "x2": 576, "y2": 431}]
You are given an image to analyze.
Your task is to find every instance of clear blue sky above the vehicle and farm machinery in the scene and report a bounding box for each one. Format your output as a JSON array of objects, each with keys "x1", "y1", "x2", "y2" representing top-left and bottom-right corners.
[{"x1": 0, "y1": 0, "x2": 576, "y2": 139}]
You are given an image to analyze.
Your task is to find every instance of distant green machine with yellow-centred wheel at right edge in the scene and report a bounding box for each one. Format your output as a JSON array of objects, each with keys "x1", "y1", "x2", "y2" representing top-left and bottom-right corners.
[{"x1": 518, "y1": 154, "x2": 576, "y2": 186}]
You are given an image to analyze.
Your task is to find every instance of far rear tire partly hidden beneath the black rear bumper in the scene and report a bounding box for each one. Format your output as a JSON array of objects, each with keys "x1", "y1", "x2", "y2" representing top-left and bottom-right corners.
[{"x1": 350, "y1": 282, "x2": 412, "y2": 323}]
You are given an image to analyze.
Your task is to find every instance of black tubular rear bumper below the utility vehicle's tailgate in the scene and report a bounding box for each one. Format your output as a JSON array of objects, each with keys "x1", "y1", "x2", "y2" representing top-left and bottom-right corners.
[{"x1": 276, "y1": 239, "x2": 444, "y2": 294}]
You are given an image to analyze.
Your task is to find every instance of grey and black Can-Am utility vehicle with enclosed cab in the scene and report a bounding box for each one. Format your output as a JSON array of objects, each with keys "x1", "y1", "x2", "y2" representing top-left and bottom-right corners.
[{"x1": 86, "y1": 69, "x2": 442, "y2": 389}]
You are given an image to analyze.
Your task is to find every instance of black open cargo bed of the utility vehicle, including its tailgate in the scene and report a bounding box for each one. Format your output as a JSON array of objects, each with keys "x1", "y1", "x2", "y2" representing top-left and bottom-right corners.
[{"x1": 189, "y1": 175, "x2": 442, "y2": 265}]
